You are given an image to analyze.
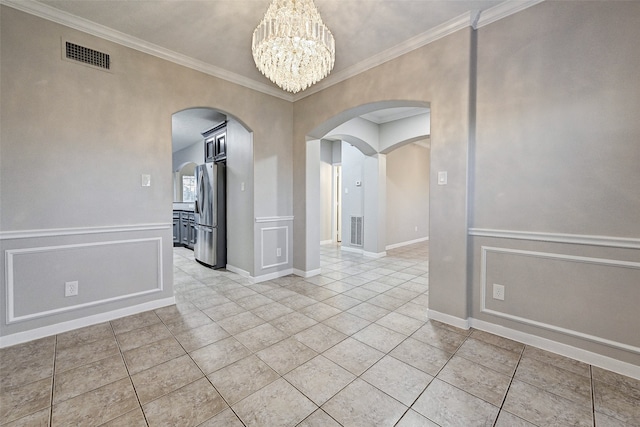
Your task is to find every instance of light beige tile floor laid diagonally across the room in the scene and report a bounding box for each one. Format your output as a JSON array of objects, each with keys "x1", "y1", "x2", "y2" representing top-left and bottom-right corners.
[{"x1": 0, "y1": 243, "x2": 640, "y2": 427}]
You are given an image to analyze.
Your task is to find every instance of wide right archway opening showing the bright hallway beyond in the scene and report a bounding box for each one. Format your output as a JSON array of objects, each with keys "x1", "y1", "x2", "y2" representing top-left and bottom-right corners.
[{"x1": 307, "y1": 103, "x2": 430, "y2": 264}]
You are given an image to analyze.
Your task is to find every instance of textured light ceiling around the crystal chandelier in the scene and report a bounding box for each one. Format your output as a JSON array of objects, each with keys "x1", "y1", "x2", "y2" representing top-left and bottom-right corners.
[{"x1": 39, "y1": 0, "x2": 504, "y2": 93}]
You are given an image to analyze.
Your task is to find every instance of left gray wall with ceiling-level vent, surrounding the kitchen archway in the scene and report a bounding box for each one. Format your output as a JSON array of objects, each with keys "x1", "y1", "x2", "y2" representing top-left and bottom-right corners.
[{"x1": 0, "y1": 6, "x2": 292, "y2": 345}]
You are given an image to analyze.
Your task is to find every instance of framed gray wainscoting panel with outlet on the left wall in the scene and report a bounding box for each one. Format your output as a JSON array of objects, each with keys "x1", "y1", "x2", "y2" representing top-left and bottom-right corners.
[{"x1": 5, "y1": 237, "x2": 163, "y2": 324}]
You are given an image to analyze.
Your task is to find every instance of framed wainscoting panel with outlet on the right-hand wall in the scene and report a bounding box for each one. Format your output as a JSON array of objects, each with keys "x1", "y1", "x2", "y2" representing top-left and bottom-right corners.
[{"x1": 474, "y1": 245, "x2": 640, "y2": 354}]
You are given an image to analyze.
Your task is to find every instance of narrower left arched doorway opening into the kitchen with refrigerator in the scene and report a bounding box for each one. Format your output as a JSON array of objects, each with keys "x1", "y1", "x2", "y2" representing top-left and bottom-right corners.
[{"x1": 171, "y1": 107, "x2": 255, "y2": 276}]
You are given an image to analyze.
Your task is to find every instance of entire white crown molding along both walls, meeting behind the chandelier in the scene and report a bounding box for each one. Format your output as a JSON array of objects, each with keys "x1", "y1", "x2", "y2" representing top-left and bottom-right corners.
[{"x1": 0, "y1": 0, "x2": 544, "y2": 102}]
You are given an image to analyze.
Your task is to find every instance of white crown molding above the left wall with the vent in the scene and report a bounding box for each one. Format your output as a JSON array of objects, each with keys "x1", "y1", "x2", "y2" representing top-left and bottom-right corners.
[{"x1": 0, "y1": 0, "x2": 293, "y2": 102}]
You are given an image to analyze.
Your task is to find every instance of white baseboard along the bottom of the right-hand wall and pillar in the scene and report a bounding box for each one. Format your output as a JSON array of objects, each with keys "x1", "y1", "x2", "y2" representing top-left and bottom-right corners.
[{"x1": 427, "y1": 310, "x2": 640, "y2": 380}]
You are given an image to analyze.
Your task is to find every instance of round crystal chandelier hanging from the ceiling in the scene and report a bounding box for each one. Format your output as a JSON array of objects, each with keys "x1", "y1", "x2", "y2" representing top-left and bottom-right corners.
[{"x1": 251, "y1": 0, "x2": 336, "y2": 93}]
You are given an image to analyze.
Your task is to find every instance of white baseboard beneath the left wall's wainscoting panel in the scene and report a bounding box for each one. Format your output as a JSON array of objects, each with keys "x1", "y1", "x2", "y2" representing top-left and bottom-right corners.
[{"x1": 0, "y1": 297, "x2": 176, "y2": 348}]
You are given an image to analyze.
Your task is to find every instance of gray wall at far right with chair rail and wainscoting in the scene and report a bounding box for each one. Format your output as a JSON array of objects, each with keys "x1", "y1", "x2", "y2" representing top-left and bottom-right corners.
[{"x1": 471, "y1": 2, "x2": 640, "y2": 364}]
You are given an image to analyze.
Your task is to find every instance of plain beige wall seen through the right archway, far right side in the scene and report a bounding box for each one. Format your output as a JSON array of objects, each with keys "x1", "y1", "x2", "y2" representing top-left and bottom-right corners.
[{"x1": 386, "y1": 143, "x2": 430, "y2": 246}]
